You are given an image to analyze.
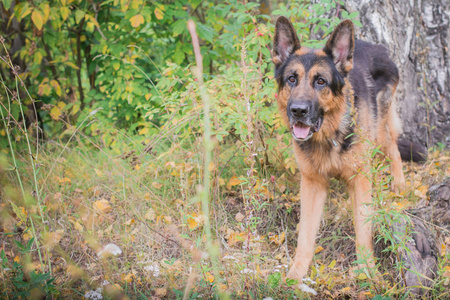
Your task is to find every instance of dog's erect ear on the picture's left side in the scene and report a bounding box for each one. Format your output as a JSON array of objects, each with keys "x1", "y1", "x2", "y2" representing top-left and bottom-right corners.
[{"x1": 272, "y1": 17, "x2": 300, "y2": 65}]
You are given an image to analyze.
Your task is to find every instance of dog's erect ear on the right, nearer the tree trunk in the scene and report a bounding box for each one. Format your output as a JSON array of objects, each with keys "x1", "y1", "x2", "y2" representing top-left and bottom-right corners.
[{"x1": 323, "y1": 20, "x2": 355, "y2": 75}]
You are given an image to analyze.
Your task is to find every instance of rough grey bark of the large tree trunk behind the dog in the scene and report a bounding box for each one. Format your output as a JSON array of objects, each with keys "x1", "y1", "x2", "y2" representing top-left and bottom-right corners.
[{"x1": 314, "y1": 0, "x2": 450, "y2": 148}]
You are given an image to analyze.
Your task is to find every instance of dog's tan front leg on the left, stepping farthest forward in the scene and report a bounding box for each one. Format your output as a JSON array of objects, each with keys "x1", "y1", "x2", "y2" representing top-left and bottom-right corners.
[{"x1": 287, "y1": 175, "x2": 328, "y2": 283}]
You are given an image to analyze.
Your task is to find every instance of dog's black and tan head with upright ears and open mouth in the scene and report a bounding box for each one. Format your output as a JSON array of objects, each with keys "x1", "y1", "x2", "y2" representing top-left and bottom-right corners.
[{"x1": 273, "y1": 17, "x2": 354, "y2": 142}]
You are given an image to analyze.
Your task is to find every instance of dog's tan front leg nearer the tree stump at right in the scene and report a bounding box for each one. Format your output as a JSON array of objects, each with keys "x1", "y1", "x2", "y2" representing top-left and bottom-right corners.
[{"x1": 348, "y1": 174, "x2": 375, "y2": 268}]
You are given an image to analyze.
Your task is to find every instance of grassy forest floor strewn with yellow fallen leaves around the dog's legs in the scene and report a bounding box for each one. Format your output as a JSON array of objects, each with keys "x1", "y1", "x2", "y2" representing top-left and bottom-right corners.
[{"x1": 0, "y1": 139, "x2": 450, "y2": 299}]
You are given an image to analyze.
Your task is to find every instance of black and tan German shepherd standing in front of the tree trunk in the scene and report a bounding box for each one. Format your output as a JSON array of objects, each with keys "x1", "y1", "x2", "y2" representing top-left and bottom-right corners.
[{"x1": 273, "y1": 17, "x2": 423, "y2": 283}]
